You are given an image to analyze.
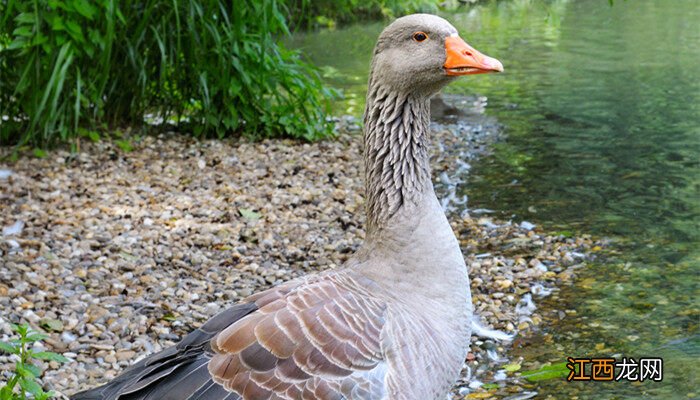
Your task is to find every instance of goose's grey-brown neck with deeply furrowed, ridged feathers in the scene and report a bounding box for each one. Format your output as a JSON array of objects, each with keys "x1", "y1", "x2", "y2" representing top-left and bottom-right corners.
[{"x1": 364, "y1": 78, "x2": 432, "y2": 235}]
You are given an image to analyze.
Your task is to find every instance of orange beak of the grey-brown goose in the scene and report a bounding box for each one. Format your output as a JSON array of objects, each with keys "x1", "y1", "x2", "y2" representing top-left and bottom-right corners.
[{"x1": 443, "y1": 36, "x2": 503, "y2": 76}]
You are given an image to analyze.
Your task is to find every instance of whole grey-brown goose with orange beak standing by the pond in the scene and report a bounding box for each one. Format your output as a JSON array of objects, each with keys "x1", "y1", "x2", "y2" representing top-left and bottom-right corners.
[{"x1": 73, "y1": 14, "x2": 503, "y2": 400}]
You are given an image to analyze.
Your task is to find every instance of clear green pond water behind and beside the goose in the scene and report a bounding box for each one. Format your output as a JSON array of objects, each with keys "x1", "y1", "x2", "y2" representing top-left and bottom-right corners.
[{"x1": 294, "y1": 0, "x2": 700, "y2": 399}]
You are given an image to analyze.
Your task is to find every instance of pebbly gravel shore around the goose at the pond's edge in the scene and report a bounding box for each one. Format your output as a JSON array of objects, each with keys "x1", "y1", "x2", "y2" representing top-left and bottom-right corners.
[{"x1": 0, "y1": 99, "x2": 594, "y2": 398}]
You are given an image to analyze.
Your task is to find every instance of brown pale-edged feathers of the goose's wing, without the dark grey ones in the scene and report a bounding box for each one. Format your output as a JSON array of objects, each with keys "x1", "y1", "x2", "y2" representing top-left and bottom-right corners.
[{"x1": 209, "y1": 270, "x2": 386, "y2": 400}]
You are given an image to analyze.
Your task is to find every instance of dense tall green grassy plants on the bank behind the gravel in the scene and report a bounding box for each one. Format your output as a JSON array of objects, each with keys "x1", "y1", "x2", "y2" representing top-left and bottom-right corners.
[{"x1": 0, "y1": 0, "x2": 340, "y2": 147}]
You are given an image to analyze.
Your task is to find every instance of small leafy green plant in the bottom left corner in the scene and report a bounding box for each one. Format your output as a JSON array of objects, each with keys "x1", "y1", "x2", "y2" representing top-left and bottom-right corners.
[{"x1": 0, "y1": 324, "x2": 68, "y2": 400}]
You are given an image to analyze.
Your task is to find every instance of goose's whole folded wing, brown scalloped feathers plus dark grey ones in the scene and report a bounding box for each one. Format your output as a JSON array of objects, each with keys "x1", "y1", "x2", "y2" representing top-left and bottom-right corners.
[{"x1": 73, "y1": 271, "x2": 386, "y2": 400}]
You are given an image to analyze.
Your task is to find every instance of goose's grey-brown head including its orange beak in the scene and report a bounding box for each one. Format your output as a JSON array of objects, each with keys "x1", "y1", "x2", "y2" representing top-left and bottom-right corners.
[{"x1": 370, "y1": 14, "x2": 503, "y2": 96}]
